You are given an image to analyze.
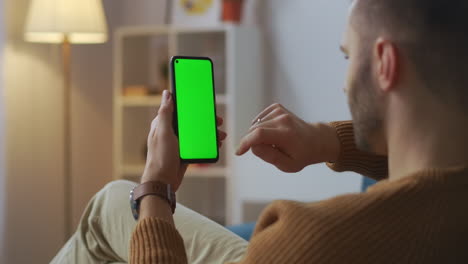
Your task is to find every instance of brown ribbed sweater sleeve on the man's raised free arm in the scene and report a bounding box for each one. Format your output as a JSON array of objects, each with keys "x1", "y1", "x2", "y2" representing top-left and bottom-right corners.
[{"x1": 327, "y1": 121, "x2": 388, "y2": 180}]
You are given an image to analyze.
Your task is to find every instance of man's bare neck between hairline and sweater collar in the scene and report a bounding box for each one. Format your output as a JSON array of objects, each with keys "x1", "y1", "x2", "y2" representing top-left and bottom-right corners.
[{"x1": 387, "y1": 104, "x2": 468, "y2": 180}]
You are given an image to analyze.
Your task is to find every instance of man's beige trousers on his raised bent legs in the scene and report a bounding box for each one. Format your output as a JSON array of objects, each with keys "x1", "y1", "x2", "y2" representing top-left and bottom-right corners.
[{"x1": 51, "y1": 181, "x2": 248, "y2": 264}]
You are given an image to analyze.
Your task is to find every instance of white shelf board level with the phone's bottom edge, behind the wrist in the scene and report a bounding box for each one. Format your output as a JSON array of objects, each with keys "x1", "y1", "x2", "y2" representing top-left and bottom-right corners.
[{"x1": 121, "y1": 165, "x2": 226, "y2": 178}]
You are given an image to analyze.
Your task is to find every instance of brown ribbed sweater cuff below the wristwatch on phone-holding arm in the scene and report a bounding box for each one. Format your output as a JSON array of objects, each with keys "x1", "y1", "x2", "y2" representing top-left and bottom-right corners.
[{"x1": 130, "y1": 218, "x2": 187, "y2": 264}]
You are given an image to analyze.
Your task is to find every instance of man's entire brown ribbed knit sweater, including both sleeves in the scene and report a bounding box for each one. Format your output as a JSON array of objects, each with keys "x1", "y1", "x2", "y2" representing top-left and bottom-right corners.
[{"x1": 130, "y1": 122, "x2": 468, "y2": 264}]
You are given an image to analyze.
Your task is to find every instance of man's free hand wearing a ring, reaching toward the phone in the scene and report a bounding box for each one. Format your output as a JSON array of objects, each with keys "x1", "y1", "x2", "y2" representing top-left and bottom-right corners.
[{"x1": 236, "y1": 104, "x2": 340, "y2": 173}]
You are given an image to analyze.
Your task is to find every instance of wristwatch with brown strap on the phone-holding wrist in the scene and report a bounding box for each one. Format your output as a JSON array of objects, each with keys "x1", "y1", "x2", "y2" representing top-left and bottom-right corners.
[{"x1": 130, "y1": 181, "x2": 176, "y2": 220}]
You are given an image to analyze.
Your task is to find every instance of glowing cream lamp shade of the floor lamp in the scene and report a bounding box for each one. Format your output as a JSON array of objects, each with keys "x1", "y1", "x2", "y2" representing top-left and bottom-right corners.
[{"x1": 24, "y1": 0, "x2": 107, "y2": 44}]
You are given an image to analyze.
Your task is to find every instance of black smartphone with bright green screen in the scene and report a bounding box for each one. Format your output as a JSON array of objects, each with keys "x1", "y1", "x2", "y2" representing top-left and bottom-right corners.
[{"x1": 170, "y1": 56, "x2": 219, "y2": 163}]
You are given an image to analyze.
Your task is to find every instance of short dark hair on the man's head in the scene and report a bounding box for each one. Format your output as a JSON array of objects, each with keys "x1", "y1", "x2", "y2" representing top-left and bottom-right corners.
[{"x1": 353, "y1": 0, "x2": 468, "y2": 111}]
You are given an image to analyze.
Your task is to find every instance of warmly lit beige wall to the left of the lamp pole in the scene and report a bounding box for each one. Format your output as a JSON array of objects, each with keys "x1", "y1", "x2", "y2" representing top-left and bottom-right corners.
[{"x1": 0, "y1": 0, "x2": 64, "y2": 264}]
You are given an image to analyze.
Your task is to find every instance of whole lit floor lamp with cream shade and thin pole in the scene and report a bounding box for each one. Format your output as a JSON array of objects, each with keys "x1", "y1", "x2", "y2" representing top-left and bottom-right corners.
[{"x1": 24, "y1": 0, "x2": 107, "y2": 238}]
